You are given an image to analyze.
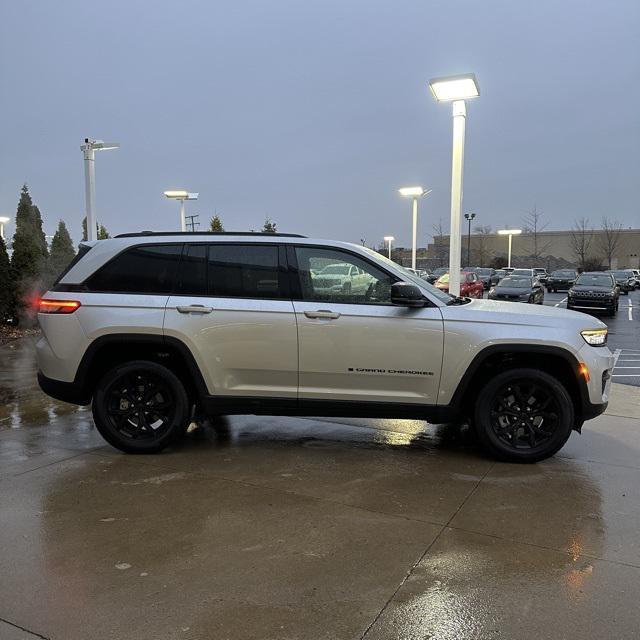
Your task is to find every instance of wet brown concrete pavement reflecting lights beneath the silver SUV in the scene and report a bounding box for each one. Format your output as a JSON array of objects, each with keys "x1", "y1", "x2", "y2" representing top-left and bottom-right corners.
[{"x1": 0, "y1": 340, "x2": 640, "y2": 640}]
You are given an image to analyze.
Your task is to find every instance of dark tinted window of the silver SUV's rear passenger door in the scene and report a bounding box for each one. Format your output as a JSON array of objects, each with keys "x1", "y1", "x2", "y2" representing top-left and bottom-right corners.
[{"x1": 208, "y1": 244, "x2": 286, "y2": 298}]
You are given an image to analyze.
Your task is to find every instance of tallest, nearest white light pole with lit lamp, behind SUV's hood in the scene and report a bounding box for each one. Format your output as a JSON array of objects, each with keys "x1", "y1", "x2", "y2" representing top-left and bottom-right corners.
[{"x1": 429, "y1": 73, "x2": 480, "y2": 296}]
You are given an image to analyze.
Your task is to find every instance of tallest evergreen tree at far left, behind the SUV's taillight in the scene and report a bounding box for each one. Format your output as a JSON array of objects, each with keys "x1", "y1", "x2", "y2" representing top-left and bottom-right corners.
[{"x1": 11, "y1": 184, "x2": 48, "y2": 321}]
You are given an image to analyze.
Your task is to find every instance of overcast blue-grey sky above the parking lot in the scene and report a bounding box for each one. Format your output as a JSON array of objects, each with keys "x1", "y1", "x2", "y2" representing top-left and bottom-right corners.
[{"x1": 0, "y1": 0, "x2": 640, "y2": 245}]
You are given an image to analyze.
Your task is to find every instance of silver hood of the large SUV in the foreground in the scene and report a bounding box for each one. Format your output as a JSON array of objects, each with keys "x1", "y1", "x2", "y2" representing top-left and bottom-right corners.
[{"x1": 440, "y1": 300, "x2": 607, "y2": 331}]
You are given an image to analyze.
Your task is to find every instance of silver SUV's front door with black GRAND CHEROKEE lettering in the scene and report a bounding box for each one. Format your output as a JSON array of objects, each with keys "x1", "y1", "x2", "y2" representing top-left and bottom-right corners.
[{"x1": 288, "y1": 246, "x2": 443, "y2": 404}]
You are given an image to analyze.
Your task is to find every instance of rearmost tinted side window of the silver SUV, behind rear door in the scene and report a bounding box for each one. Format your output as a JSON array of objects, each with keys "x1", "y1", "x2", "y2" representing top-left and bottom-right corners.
[{"x1": 87, "y1": 244, "x2": 182, "y2": 293}]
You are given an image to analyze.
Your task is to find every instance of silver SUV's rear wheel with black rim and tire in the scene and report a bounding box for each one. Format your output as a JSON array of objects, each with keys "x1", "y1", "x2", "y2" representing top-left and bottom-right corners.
[{"x1": 92, "y1": 360, "x2": 191, "y2": 453}]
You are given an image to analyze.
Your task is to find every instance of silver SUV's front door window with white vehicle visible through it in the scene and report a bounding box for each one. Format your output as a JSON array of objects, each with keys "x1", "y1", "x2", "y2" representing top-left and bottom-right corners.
[{"x1": 295, "y1": 247, "x2": 394, "y2": 304}]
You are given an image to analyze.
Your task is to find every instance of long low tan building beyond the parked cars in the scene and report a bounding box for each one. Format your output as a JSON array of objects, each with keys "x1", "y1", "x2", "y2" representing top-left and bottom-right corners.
[{"x1": 393, "y1": 229, "x2": 640, "y2": 269}]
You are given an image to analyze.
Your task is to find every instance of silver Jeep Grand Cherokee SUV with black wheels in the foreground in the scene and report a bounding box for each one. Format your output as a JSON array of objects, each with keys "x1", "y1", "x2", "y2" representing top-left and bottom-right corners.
[{"x1": 37, "y1": 232, "x2": 613, "y2": 462}]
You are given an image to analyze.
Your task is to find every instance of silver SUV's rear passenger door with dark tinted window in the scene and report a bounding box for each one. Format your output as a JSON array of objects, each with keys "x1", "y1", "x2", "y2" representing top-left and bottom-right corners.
[{"x1": 164, "y1": 242, "x2": 298, "y2": 398}]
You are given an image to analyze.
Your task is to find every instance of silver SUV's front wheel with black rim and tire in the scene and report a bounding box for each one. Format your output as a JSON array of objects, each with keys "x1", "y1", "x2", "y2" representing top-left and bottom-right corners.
[{"x1": 474, "y1": 368, "x2": 575, "y2": 463}]
